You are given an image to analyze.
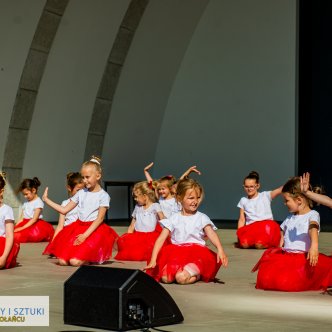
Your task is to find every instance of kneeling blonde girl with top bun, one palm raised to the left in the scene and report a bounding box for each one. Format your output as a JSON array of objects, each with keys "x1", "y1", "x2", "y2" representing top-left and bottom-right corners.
[{"x1": 43, "y1": 156, "x2": 118, "y2": 266}]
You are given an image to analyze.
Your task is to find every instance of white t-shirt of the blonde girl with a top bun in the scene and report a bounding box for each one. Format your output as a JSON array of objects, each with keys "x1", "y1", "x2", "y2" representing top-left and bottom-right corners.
[{"x1": 70, "y1": 188, "x2": 111, "y2": 221}]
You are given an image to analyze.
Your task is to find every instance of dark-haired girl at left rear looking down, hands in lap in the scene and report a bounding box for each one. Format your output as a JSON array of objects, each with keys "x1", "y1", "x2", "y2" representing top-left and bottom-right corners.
[{"x1": 14, "y1": 177, "x2": 54, "y2": 243}]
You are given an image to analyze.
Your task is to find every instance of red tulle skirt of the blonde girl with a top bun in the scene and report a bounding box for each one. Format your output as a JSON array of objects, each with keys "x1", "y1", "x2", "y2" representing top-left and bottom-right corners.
[{"x1": 43, "y1": 220, "x2": 119, "y2": 264}]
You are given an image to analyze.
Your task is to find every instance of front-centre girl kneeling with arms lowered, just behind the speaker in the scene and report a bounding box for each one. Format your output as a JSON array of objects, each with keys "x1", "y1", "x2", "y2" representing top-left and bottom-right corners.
[{"x1": 145, "y1": 179, "x2": 228, "y2": 284}]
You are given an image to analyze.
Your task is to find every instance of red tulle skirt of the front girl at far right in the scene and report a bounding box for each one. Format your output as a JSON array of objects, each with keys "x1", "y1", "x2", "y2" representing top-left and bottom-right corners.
[{"x1": 252, "y1": 248, "x2": 332, "y2": 292}]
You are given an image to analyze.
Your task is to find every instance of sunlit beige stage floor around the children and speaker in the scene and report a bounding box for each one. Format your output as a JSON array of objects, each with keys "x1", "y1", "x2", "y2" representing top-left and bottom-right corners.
[{"x1": 0, "y1": 227, "x2": 332, "y2": 332}]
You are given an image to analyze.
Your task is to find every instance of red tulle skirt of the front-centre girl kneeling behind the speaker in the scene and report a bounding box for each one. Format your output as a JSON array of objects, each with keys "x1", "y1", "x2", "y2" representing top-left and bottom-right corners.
[{"x1": 147, "y1": 243, "x2": 221, "y2": 282}]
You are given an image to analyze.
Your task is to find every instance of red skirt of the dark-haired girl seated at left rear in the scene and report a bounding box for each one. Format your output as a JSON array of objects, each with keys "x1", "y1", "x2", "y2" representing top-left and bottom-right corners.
[{"x1": 14, "y1": 219, "x2": 54, "y2": 243}]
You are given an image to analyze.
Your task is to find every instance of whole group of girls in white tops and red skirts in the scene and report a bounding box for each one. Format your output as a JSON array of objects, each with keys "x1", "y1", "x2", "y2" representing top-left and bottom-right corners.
[{"x1": 0, "y1": 156, "x2": 332, "y2": 291}]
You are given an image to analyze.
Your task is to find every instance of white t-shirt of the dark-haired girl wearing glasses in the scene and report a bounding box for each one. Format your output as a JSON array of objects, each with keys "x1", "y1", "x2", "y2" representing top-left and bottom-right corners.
[{"x1": 237, "y1": 191, "x2": 273, "y2": 225}]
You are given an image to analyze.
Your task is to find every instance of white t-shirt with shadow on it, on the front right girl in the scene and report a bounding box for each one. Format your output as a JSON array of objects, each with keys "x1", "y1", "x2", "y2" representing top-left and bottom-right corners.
[{"x1": 280, "y1": 210, "x2": 320, "y2": 252}]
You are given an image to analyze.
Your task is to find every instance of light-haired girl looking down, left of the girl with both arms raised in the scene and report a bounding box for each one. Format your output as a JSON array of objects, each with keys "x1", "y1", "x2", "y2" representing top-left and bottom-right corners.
[{"x1": 115, "y1": 181, "x2": 165, "y2": 261}]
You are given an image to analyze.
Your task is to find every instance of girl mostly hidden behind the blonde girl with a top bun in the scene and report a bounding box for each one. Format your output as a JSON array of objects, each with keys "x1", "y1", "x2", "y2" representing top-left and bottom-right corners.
[{"x1": 43, "y1": 172, "x2": 84, "y2": 255}]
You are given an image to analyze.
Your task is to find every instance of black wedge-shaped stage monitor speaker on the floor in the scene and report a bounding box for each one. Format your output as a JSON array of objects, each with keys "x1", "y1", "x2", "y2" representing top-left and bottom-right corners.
[{"x1": 64, "y1": 266, "x2": 183, "y2": 331}]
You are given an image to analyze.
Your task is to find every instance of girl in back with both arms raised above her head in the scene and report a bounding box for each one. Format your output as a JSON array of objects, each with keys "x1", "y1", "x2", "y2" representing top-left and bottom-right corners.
[{"x1": 144, "y1": 162, "x2": 201, "y2": 218}]
